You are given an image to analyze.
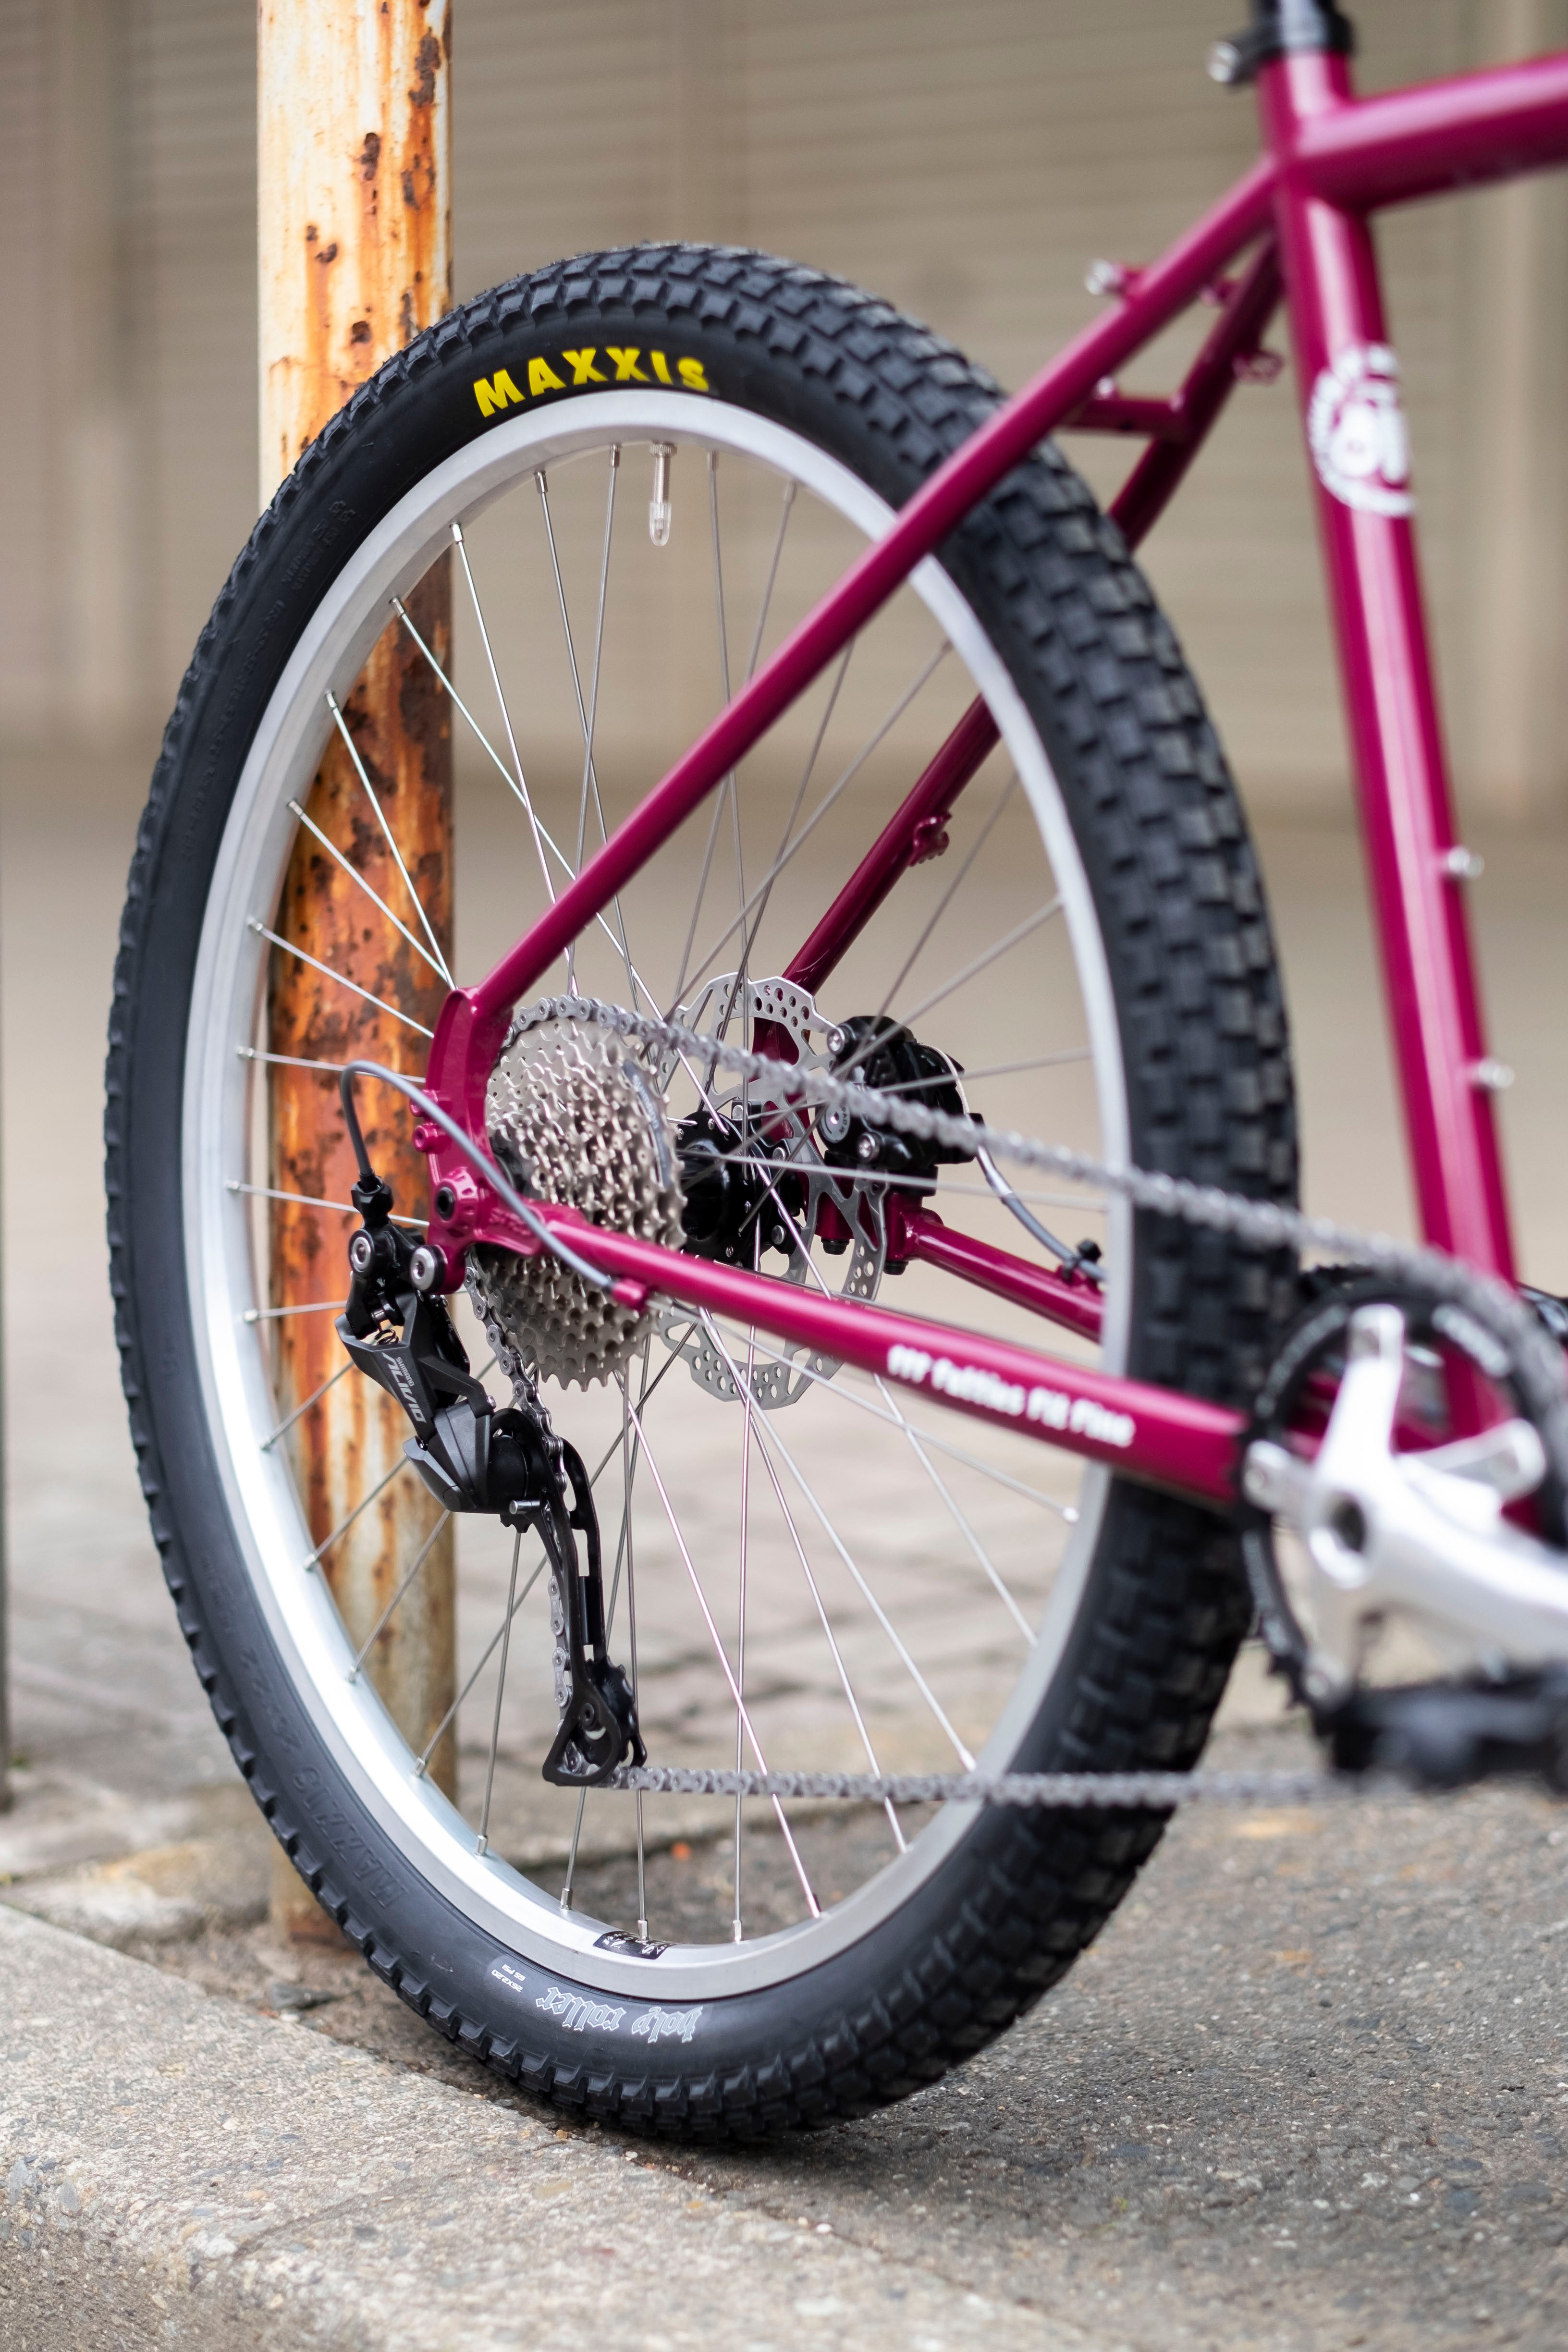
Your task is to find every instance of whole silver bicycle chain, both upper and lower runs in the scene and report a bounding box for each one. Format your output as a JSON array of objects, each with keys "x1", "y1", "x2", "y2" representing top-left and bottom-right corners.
[{"x1": 486, "y1": 995, "x2": 1568, "y2": 1811}]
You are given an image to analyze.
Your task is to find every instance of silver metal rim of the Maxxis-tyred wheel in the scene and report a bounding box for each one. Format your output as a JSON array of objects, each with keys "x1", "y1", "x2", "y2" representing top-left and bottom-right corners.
[{"x1": 181, "y1": 393, "x2": 1128, "y2": 1999}]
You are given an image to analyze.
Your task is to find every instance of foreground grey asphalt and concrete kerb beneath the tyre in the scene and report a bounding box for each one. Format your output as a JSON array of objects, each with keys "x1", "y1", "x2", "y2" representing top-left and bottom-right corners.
[{"x1": 0, "y1": 1731, "x2": 1568, "y2": 2352}]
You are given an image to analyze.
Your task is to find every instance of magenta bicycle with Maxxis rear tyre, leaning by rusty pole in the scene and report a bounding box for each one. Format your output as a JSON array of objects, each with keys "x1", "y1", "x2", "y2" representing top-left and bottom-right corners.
[{"x1": 108, "y1": 0, "x2": 1568, "y2": 2136}]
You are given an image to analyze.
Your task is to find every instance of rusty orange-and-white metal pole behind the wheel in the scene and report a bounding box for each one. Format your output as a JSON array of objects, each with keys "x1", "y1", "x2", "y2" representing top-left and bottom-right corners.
[{"x1": 258, "y1": 0, "x2": 456, "y2": 1943}]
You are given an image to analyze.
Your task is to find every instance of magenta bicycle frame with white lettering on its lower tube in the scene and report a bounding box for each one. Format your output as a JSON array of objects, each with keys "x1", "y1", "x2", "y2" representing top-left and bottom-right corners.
[{"x1": 418, "y1": 37, "x2": 1568, "y2": 1503}]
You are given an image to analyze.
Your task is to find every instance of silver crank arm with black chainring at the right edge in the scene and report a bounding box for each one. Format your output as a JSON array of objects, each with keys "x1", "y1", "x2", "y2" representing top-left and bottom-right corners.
[{"x1": 1241, "y1": 1279, "x2": 1568, "y2": 1788}]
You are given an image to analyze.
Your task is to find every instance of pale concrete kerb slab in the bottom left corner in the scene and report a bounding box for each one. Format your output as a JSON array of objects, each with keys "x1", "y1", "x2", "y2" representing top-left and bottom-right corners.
[{"x1": 0, "y1": 1910, "x2": 1093, "y2": 2352}]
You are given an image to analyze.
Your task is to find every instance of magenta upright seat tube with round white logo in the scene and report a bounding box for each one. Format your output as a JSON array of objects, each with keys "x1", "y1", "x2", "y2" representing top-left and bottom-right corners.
[{"x1": 1258, "y1": 54, "x2": 1514, "y2": 1279}]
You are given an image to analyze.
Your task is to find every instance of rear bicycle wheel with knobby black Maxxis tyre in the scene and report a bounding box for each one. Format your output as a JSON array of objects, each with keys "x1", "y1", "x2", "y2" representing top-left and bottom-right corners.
[{"x1": 108, "y1": 247, "x2": 1293, "y2": 2133}]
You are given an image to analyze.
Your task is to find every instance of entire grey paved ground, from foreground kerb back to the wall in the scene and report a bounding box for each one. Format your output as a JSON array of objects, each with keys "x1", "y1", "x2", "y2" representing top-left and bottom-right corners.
[{"x1": 0, "y1": 776, "x2": 1568, "y2": 2352}]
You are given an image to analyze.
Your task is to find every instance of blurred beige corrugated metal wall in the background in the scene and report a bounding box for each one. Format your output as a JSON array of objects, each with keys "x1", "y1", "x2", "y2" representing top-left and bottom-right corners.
[{"x1": 0, "y1": 0, "x2": 1568, "y2": 807}]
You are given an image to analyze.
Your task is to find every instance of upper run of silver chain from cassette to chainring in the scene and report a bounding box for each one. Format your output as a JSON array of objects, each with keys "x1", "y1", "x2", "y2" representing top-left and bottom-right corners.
[{"x1": 517, "y1": 995, "x2": 1568, "y2": 1495}]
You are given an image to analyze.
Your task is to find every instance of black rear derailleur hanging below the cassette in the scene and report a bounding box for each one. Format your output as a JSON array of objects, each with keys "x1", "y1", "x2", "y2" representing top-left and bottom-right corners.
[{"x1": 339, "y1": 1176, "x2": 647, "y2": 1788}]
